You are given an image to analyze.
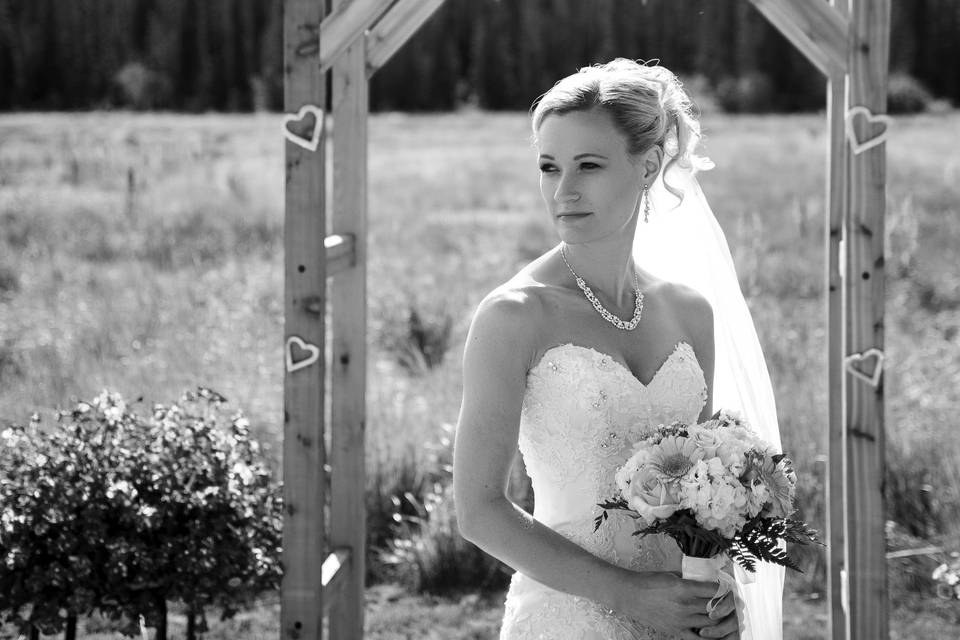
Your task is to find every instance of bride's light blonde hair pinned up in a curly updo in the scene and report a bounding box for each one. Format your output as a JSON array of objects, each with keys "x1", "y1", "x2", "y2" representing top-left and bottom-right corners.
[{"x1": 531, "y1": 58, "x2": 701, "y2": 198}]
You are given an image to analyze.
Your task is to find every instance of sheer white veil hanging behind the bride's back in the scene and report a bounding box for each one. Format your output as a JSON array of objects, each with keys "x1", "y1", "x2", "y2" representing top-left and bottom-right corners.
[{"x1": 633, "y1": 152, "x2": 784, "y2": 640}]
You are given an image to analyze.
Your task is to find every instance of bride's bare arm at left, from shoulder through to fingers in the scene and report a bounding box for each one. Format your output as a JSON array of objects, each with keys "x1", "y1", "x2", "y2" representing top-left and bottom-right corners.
[{"x1": 453, "y1": 292, "x2": 716, "y2": 638}]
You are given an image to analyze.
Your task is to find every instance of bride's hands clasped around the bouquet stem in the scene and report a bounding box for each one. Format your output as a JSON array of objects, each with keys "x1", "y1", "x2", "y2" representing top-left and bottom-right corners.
[{"x1": 615, "y1": 571, "x2": 738, "y2": 640}]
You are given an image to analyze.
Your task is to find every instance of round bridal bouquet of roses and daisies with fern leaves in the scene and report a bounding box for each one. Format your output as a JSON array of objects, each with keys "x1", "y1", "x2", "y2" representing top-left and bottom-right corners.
[{"x1": 594, "y1": 410, "x2": 817, "y2": 636}]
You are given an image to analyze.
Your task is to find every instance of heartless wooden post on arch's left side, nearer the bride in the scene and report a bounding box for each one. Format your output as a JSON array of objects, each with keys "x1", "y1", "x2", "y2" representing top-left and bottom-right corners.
[{"x1": 329, "y1": 23, "x2": 368, "y2": 640}]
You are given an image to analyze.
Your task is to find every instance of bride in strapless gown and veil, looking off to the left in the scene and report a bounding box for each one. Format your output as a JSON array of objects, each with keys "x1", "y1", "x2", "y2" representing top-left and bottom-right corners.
[{"x1": 454, "y1": 59, "x2": 782, "y2": 640}]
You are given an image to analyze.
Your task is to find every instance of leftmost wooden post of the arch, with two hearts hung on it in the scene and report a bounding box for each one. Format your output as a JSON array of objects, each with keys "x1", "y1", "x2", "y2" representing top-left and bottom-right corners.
[{"x1": 278, "y1": 0, "x2": 326, "y2": 640}]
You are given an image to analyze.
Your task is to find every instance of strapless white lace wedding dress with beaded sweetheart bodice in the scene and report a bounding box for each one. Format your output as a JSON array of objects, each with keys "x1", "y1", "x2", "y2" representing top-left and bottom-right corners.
[{"x1": 500, "y1": 342, "x2": 707, "y2": 640}]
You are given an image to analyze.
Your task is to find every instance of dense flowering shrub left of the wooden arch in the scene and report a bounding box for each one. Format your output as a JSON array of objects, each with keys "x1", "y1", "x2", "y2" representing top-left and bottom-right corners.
[{"x1": 0, "y1": 388, "x2": 282, "y2": 636}]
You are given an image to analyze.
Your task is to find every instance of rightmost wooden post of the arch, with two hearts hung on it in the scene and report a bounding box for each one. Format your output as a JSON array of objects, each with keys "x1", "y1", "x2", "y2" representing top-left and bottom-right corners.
[{"x1": 844, "y1": 0, "x2": 890, "y2": 640}]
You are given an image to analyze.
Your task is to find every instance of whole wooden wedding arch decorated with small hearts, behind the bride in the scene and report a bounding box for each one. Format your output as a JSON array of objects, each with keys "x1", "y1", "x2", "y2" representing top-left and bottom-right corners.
[{"x1": 280, "y1": 0, "x2": 890, "y2": 640}]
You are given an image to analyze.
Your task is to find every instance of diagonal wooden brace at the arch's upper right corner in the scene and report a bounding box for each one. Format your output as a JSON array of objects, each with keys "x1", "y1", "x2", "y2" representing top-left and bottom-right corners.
[{"x1": 750, "y1": 0, "x2": 849, "y2": 78}]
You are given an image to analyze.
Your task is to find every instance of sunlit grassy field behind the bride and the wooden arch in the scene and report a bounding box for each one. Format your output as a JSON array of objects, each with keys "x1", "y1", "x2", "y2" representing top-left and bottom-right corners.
[{"x1": 0, "y1": 112, "x2": 960, "y2": 639}]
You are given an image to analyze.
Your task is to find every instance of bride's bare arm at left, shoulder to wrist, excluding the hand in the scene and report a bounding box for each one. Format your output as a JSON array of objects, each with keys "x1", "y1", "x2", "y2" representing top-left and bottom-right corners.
[{"x1": 453, "y1": 292, "x2": 615, "y2": 606}]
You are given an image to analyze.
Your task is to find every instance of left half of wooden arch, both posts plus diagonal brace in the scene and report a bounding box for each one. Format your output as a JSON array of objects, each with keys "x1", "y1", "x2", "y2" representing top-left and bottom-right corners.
[{"x1": 280, "y1": 0, "x2": 452, "y2": 640}]
